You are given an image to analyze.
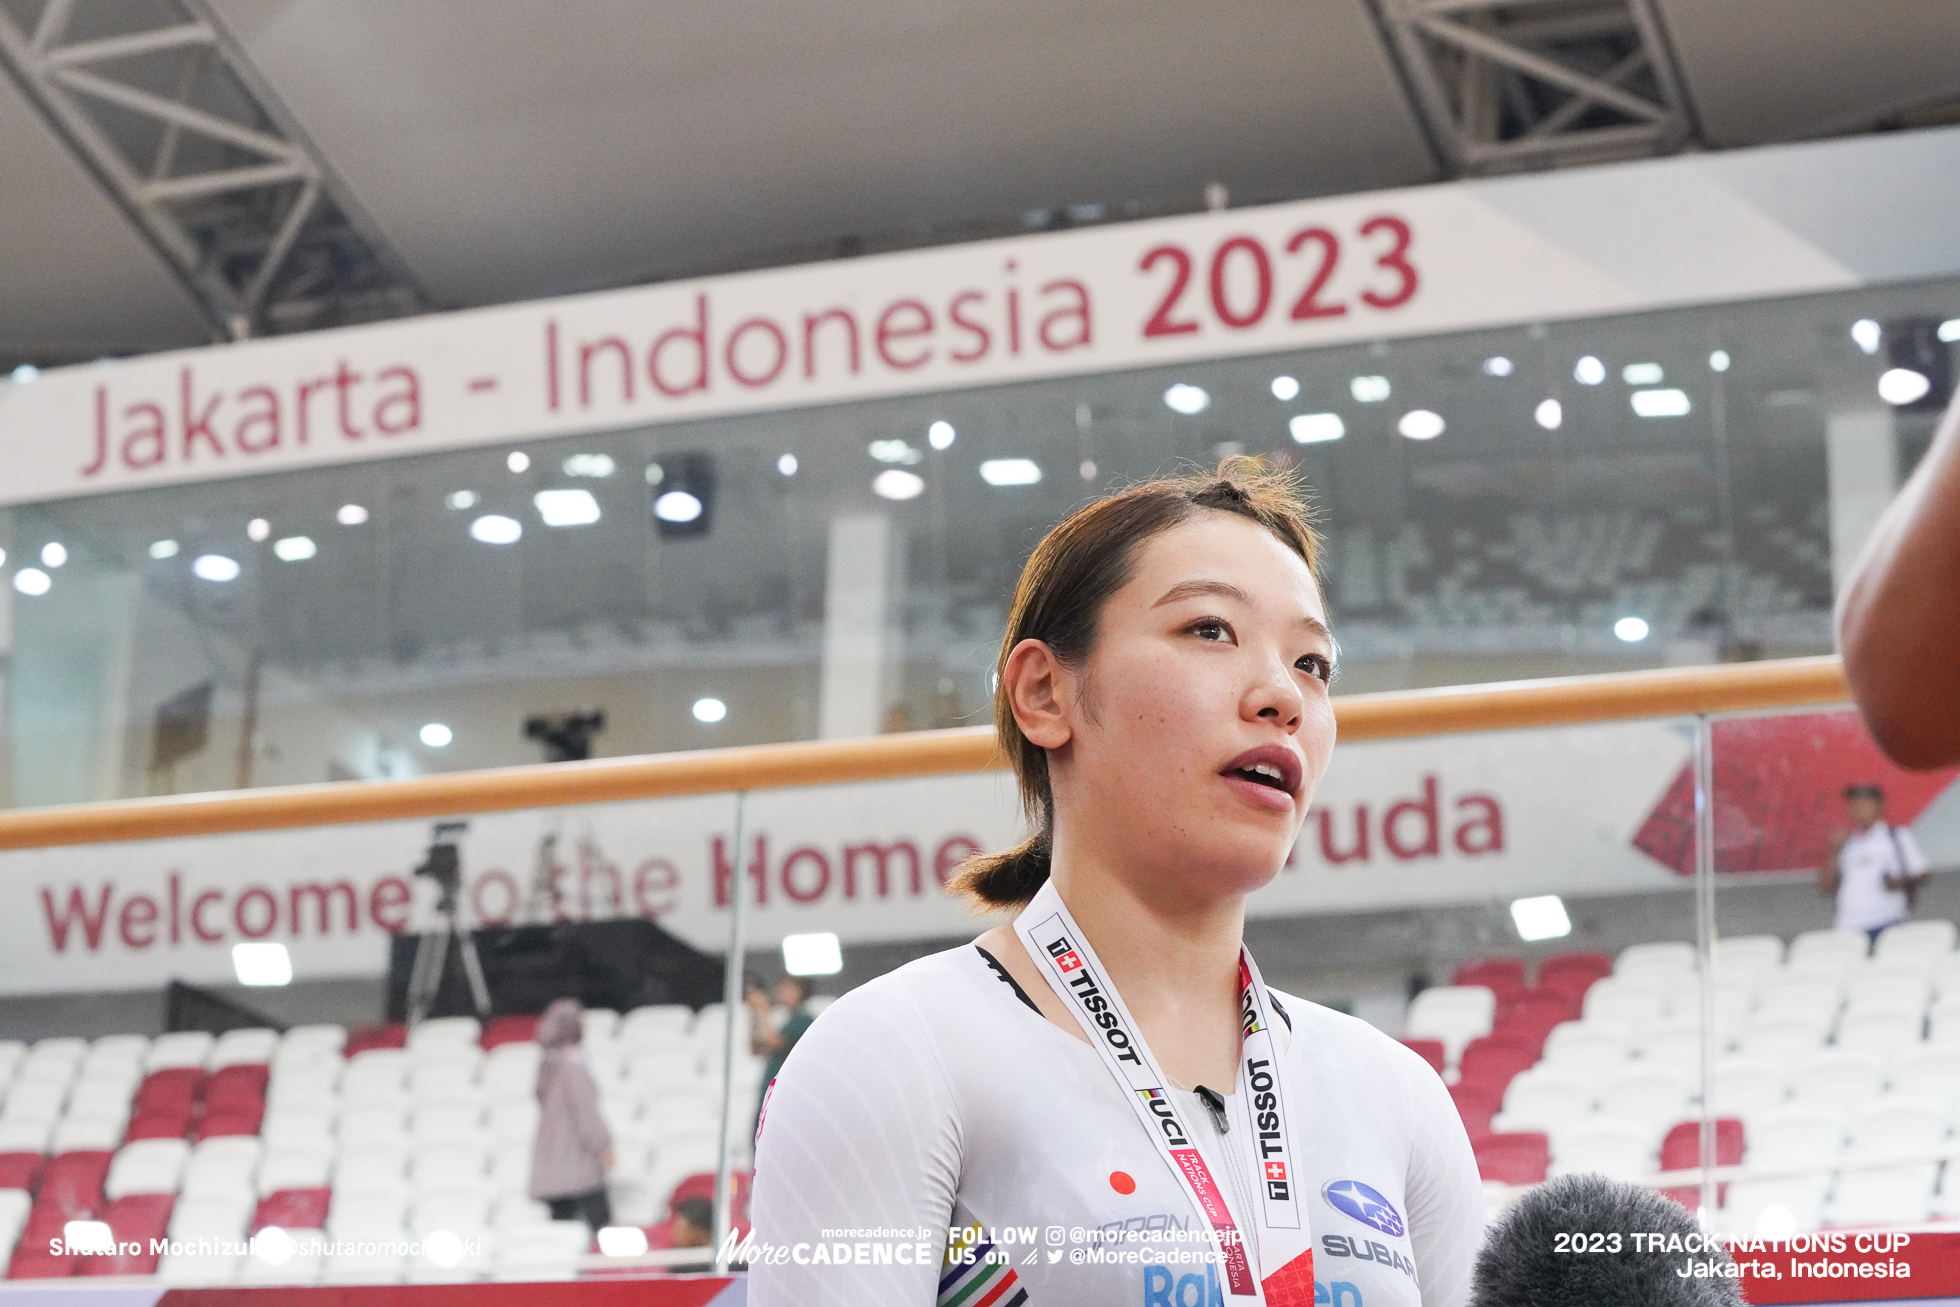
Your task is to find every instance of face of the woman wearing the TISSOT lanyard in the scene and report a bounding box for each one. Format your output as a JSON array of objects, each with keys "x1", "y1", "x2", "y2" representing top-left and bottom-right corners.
[{"x1": 1037, "y1": 511, "x2": 1335, "y2": 897}]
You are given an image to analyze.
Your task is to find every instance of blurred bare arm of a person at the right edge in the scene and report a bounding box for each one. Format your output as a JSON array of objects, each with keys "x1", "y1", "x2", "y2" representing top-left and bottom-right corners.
[{"x1": 1838, "y1": 380, "x2": 1960, "y2": 768}]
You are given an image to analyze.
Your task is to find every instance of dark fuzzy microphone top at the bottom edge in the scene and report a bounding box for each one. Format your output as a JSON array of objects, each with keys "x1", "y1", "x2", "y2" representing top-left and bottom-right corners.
[{"x1": 1470, "y1": 1176, "x2": 1742, "y2": 1307}]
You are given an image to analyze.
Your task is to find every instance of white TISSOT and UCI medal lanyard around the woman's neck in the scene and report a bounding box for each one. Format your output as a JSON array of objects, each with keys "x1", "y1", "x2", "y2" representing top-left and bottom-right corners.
[{"x1": 1013, "y1": 880, "x2": 1313, "y2": 1307}]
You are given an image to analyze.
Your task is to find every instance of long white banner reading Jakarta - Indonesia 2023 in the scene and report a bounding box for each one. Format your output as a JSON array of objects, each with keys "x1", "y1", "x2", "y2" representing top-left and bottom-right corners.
[{"x1": 0, "y1": 131, "x2": 1960, "y2": 504}]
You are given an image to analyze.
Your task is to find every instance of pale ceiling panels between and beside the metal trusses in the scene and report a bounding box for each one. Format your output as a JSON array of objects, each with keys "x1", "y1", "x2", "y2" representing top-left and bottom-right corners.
[{"x1": 0, "y1": 0, "x2": 1960, "y2": 359}]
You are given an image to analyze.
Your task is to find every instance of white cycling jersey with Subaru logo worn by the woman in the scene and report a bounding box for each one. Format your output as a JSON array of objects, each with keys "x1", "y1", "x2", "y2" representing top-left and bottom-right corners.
[{"x1": 749, "y1": 944, "x2": 1484, "y2": 1307}]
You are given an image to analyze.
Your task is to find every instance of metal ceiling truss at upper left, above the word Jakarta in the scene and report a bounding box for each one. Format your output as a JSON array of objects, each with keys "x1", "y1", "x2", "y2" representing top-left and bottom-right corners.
[{"x1": 0, "y1": 0, "x2": 429, "y2": 339}]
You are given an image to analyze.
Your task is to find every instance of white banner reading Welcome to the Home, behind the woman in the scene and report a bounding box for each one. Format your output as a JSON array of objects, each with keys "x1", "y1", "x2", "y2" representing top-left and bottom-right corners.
[{"x1": 0, "y1": 723, "x2": 1688, "y2": 993}]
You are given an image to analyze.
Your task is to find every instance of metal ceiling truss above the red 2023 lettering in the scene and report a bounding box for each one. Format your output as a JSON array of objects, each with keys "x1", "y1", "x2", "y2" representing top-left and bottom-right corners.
[{"x1": 1376, "y1": 0, "x2": 1697, "y2": 176}]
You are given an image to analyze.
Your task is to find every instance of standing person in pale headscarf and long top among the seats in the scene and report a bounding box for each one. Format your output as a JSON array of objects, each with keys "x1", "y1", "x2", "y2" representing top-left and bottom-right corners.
[{"x1": 529, "y1": 999, "x2": 612, "y2": 1231}]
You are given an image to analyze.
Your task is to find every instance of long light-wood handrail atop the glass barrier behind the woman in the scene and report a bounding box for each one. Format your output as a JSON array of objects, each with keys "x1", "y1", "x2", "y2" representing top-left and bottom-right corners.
[{"x1": 0, "y1": 658, "x2": 1848, "y2": 848}]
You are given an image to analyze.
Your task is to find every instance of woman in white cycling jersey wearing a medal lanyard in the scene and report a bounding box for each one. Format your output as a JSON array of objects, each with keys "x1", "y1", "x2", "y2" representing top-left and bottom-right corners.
[{"x1": 749, "y1": 459, "x2": 1484, "y2": 1307}]
